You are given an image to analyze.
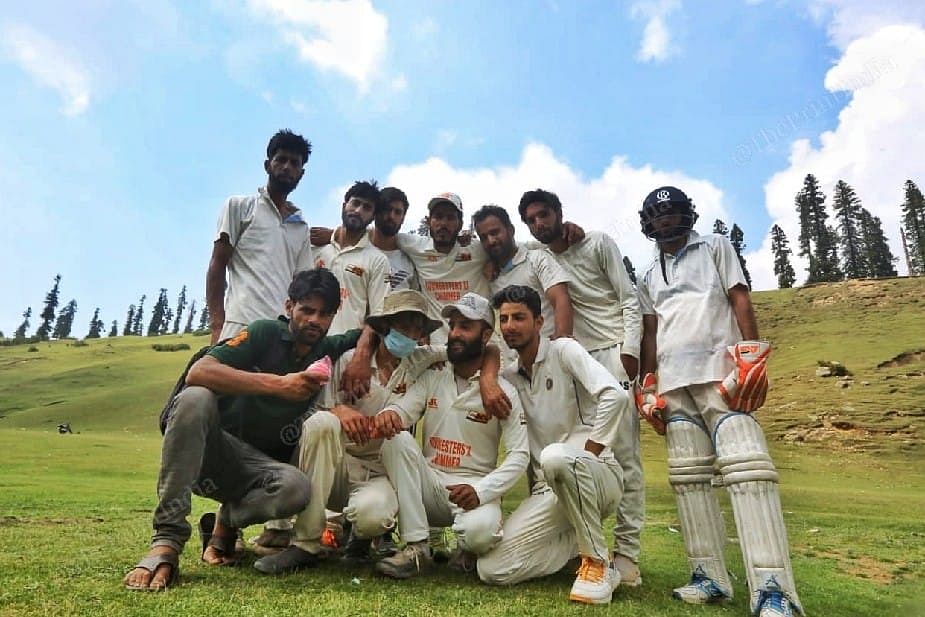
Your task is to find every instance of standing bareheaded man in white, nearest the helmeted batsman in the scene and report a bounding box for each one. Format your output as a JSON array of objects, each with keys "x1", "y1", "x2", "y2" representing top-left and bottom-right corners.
[{"x1": 518, "y1": 189, "x2": 645, "y2": 587}]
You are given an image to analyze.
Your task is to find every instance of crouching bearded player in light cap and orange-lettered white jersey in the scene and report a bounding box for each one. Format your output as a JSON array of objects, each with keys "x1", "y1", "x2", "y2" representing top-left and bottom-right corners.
[{"x1": 368, "y1": 293, "x2": 529, "y2": 579}]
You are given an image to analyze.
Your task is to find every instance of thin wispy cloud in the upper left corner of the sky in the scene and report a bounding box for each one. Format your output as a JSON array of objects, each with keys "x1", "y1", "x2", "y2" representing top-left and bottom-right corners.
[{"x1": 2, "y1": 24, "x2": 91, "y2": 116}]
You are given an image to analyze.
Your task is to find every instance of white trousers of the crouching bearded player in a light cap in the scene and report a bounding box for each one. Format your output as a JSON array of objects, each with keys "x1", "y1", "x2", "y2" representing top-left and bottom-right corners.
[{"x1": 380, "y1": 432, "x2": 501, "y2": 555}]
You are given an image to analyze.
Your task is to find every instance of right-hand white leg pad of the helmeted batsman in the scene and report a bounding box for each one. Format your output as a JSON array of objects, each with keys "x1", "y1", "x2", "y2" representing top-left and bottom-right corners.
[{"x1": 715, "y1": 413, "x2": 803, "y2": 613}]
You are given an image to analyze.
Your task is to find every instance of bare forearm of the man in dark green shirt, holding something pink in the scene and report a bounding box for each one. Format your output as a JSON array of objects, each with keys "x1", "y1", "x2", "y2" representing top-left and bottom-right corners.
[{"x1": 186, "y1": 356, "x2": 321, "y2": 401}]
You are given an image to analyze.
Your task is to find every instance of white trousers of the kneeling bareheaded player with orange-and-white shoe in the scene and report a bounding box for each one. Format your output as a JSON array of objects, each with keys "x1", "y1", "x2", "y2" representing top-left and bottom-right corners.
[{"x1": 478, "y1": 443, "x2": 623, "y2": 585}]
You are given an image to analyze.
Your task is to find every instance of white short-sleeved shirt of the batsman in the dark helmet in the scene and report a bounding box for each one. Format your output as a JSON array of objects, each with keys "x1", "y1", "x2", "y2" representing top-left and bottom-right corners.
[{"x1": 639, "y1": 231, "x2": 746, "y2": 393}]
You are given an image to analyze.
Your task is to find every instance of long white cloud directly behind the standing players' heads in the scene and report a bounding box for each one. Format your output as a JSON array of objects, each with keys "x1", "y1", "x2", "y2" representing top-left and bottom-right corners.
[{"x1": 384, "y1": 143, "x2": 728, "y2": 271}]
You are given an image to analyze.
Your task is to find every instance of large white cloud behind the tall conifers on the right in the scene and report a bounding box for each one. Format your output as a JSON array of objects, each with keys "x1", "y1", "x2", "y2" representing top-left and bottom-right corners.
[{"x1": 746, "y1": 25, "x2": 925, "y2": 289}]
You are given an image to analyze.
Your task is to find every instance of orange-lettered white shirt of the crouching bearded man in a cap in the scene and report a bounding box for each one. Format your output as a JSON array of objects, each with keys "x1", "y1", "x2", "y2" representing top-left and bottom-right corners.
[{"x1": 387, "y1": 363, "x2": 530, "y2": 503}]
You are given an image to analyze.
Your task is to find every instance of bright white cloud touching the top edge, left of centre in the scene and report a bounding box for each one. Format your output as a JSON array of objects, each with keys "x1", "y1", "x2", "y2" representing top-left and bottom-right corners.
[{"x1": 248, "y1": 0, "x2": 388, "y2": 93}]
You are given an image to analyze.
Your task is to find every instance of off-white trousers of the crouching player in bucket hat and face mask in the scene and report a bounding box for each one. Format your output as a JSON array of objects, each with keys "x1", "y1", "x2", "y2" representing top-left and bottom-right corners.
[{"x1": 292, "y1": 411, "x2": 398, "y2": 554}]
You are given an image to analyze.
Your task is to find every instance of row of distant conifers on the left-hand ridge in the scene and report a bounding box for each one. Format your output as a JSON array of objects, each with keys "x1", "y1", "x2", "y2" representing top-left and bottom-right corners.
[{"x1": 6, "y1": 274, "x2": 202, "y2": 343}]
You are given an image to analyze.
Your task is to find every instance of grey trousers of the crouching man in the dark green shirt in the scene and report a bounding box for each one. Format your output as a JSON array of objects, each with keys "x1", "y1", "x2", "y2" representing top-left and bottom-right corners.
[{"x1": 151, "y1": 386, "x2": 309, "y2": 552}]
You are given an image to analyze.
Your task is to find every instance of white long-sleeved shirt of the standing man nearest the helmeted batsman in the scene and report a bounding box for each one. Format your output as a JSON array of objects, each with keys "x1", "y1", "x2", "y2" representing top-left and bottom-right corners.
[{"x1": 543, "y1": 231, "x2": 642, "y2": 358}]
